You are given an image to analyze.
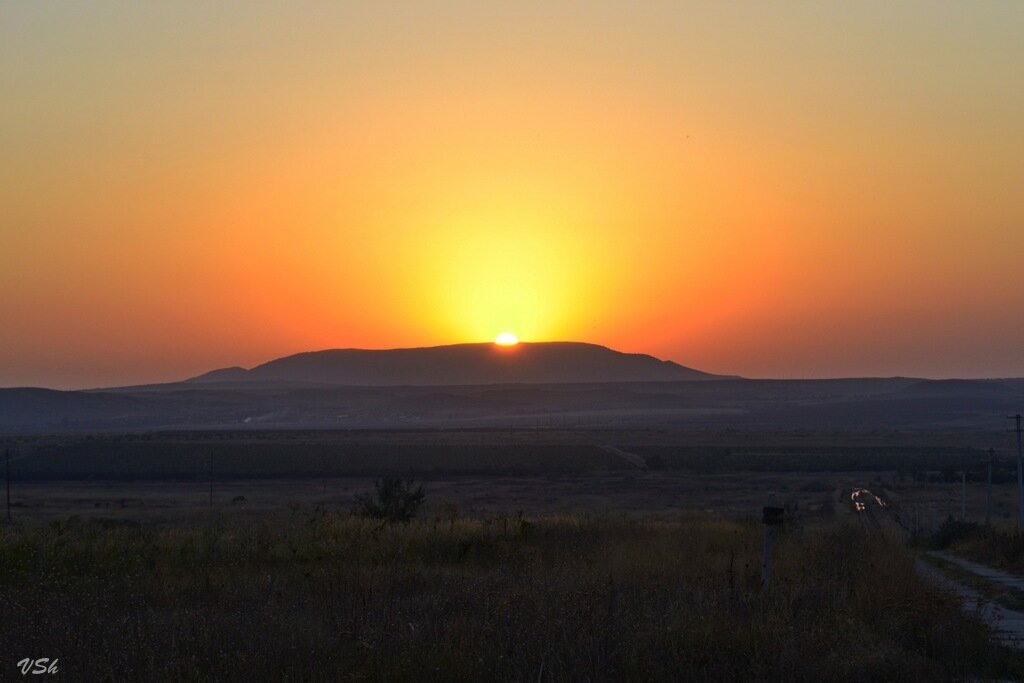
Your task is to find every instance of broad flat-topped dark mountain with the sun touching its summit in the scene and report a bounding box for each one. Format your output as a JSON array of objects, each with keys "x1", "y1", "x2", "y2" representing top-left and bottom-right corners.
[{"x1": 186, "y1": 342, "x2": 727, "y2": 386}]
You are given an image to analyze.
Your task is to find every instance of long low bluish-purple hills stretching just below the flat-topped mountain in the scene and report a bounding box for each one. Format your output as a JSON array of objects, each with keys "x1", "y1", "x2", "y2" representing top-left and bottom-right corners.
[{"x1": 0, "y1": 370, "x2": 1024, "y2": 430}]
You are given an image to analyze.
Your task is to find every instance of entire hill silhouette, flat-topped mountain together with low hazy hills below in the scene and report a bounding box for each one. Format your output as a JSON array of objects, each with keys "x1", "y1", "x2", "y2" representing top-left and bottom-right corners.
[{"x1": 9, "y1": 342, "x2": 1024, "y2": 432}]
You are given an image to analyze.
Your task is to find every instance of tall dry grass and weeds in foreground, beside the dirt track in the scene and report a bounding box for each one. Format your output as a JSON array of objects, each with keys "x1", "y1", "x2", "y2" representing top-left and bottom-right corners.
[{"x1": 0, "y1": 509, "x2": 1024, "y2": 681}]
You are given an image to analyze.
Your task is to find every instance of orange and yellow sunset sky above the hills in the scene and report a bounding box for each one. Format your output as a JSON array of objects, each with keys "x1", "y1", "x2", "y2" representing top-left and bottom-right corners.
[{"x1": 0, "y1": 0, "x2": 1024, "y2": 388}]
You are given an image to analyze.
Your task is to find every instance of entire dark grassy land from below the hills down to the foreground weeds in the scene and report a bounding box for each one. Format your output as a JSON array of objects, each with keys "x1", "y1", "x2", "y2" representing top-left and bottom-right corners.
[{"x1": 0, "y1": 430, "x2": 1024, "y2": 681}]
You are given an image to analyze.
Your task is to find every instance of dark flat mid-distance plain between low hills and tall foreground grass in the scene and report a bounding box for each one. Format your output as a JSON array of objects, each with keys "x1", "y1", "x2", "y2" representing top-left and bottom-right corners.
[{"x1": 6, "y1": 429, "x2": 1016, "y2": 531}]
